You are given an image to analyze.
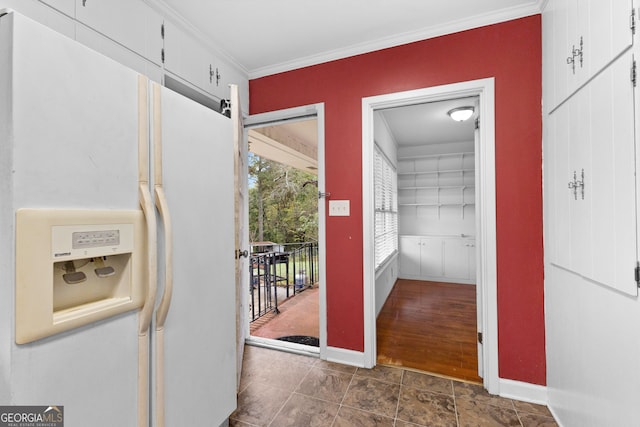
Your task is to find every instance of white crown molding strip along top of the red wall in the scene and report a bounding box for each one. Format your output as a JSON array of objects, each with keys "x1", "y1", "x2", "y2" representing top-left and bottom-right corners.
[{"x1": 249, "y1": 0, "x2": 548, "y2": 80}]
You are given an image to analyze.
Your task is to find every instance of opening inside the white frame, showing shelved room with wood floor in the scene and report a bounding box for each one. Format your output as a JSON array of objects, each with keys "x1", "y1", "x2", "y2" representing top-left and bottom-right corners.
[{"x1": 374, "y1": 96, "x2": 481, "y2": 382}]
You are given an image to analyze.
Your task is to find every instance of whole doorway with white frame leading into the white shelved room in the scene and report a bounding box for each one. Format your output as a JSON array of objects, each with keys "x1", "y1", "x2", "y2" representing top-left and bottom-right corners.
[{"x1": 363, "y1": 79, "x2": 499, "y2": 391}]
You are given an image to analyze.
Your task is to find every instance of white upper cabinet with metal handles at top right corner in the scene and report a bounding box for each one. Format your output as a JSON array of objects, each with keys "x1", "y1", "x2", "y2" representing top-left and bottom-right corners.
[{"x1": 543, "y1": 0, "x2": 633, "y2": 112}]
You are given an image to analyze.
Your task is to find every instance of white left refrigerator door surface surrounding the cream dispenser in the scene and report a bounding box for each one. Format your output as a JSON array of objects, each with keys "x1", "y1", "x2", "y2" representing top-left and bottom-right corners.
[{"x1": 0, "y1": 13, "x2": 138, "y2": 427}]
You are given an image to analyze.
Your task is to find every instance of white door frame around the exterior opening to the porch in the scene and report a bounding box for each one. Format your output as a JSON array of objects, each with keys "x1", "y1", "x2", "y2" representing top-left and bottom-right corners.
[{"x1": 243, "y1": 103, "x2": 327, "y2": 359}]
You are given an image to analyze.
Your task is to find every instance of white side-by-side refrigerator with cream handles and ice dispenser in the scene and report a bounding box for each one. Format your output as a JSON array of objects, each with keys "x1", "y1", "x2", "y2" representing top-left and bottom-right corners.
[{"x1": 0, "y1": 12, "x2": 236, "y2": 427}]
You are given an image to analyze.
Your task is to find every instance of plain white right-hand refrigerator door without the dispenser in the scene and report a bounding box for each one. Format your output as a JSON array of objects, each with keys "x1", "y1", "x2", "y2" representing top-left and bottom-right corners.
[{"x1": 152, "y1": 88, "x2": 236, "y2": 426}]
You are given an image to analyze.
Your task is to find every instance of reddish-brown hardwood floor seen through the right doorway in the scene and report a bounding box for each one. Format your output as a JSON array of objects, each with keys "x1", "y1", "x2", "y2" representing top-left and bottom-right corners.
[{"x1": 377, "y1": 279, "x2": 482, "y2": 382}]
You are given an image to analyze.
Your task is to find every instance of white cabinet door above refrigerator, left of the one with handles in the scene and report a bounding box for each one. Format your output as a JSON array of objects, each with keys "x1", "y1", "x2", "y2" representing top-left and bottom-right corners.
[{"x1": 76, "y1": 0, "x2": 162, "y2": 64}]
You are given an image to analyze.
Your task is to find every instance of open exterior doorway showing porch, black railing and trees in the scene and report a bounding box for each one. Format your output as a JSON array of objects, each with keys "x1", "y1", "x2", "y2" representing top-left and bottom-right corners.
[{"x1": 245, "y1": 106, "x2": 326, "y2": 355}]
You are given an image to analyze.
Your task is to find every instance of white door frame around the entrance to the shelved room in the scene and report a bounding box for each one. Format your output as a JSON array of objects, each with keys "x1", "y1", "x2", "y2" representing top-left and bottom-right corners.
[{"x1": 362, "y1": 77, "x2": 500, "y2": 394}]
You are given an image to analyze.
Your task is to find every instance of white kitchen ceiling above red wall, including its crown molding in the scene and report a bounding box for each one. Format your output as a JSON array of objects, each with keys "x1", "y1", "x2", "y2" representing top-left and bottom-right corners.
[{"x1": 148, "y1": 0, "x2": 544, "y2": 78}]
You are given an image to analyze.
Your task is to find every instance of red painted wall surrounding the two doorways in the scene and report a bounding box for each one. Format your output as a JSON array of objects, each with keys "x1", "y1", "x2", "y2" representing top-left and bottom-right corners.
[{"x1": 249, "y1": 15, "x2": 546, "y2": 385}]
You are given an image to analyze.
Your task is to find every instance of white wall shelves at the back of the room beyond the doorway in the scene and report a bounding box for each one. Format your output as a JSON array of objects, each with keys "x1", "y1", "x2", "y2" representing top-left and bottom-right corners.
[{"x1": 398, "y1": 152, "x2": 475, "y2": 218}]
